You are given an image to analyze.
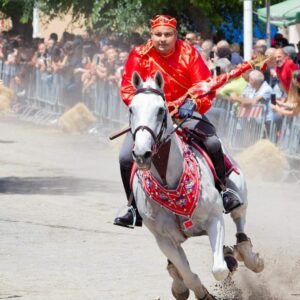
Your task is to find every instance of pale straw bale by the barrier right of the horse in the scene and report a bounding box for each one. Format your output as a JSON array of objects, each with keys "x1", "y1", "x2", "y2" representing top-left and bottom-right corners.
[{"x1": 235, "y1": 140, "x2": 289, "y2": 181}]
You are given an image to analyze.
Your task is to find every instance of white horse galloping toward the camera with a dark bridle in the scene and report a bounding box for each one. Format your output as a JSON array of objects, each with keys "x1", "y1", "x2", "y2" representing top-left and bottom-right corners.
[{"x1": 129, "y1": 72, "x2": 263, "y2": 300}]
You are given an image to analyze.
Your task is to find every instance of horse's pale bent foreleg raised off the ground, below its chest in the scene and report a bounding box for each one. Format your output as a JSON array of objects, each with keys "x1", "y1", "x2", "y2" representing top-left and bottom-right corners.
[{"x1": 207, "y1": 215, "x2": 229, "y2": 280}]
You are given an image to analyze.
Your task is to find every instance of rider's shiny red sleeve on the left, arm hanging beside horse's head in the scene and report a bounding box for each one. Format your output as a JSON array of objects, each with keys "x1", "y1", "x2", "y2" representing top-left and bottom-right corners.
[{"x1": 120, "y1": 50, "x2": 141, "y2": 106}]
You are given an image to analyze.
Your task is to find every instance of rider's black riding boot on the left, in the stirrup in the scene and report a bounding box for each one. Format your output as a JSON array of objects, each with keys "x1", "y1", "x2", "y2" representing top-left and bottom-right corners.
[{"x1": 114, "y1": 165, "x2": 143, "y2": 228}]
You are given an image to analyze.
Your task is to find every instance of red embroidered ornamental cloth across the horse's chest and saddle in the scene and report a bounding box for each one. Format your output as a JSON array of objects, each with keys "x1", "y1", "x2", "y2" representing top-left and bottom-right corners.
[{"x1": 130, "y1": 139, "x2": 238, "y2": 218}]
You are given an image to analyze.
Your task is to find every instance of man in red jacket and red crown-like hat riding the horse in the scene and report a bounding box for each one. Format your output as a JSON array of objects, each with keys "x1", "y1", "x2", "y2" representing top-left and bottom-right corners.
[{"x1": 114, "y1": 15, "x2": 242, "y2": 227}]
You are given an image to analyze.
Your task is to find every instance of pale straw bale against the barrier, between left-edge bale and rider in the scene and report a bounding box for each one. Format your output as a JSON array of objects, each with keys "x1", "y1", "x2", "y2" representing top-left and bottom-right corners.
[{"x1": 58, "y1": 102, "x2": 97, "y2": 133}]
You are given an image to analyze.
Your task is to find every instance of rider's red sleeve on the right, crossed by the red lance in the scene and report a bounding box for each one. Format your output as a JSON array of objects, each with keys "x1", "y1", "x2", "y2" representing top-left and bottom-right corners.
[{"x1": 190, "y1": 50, "x2": 216, "y2": 114}]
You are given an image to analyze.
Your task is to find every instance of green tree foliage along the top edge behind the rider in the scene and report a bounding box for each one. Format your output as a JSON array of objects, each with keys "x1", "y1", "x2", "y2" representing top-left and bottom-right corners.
[{"x1": 0, "y1": 0, "x2": 282, "y2": 37}]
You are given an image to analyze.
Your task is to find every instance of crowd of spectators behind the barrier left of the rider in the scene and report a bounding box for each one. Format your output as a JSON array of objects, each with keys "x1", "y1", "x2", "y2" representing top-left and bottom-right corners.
[{"x1": 0, "y1": 29, "x2": 134, "y2": 106}]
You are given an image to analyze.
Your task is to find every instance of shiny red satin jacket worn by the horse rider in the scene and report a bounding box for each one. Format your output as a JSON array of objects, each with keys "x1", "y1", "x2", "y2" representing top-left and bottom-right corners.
[{"x1": 121, "y1": 40, "x2": 215, "y2": 114}]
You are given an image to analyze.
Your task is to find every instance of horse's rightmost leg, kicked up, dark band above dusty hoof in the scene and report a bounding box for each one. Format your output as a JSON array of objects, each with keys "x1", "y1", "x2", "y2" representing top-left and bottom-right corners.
[{"x1": 231, "y1": 207, "x2": 264, "y2": 273}]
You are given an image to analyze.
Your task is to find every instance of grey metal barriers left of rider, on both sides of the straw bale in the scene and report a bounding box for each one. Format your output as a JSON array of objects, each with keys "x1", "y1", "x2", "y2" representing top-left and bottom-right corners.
[{"x1": 0, "y1": 61, "x2": 128, "y2": 127}]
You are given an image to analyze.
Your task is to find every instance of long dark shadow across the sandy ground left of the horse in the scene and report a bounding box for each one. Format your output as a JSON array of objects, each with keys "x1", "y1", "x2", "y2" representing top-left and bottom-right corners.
[{"x1": 0, "y1": 176, "x2": 121, "y2": 195}]
